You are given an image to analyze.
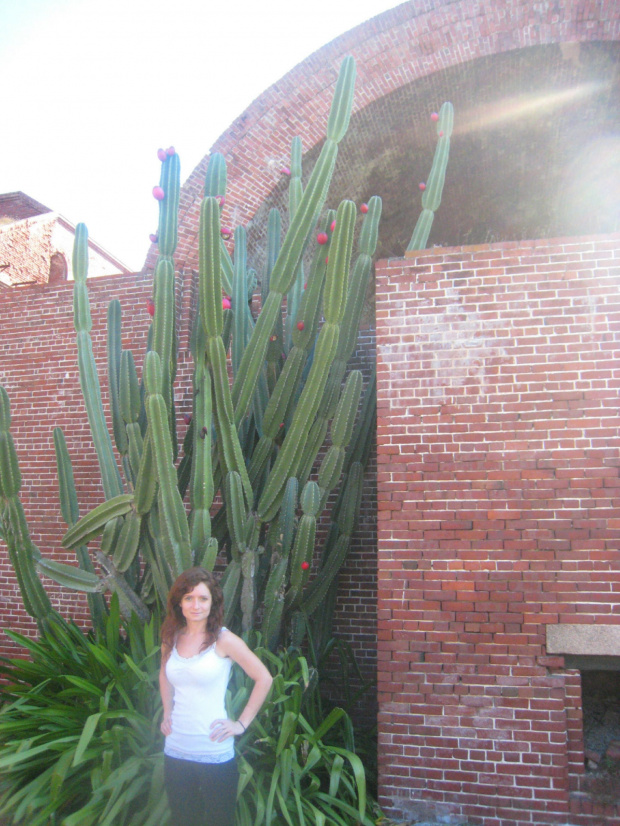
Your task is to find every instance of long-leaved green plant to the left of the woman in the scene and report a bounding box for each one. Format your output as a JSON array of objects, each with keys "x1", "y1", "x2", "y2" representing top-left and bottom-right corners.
[{"x1": 0, "y1": 598, "x2": 166, "y2": 826}]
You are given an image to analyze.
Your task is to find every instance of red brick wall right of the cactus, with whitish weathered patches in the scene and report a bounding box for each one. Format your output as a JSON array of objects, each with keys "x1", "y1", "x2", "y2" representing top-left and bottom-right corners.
[{"x1": 377, "y1": 236, "x2": 620, "y2": 826}]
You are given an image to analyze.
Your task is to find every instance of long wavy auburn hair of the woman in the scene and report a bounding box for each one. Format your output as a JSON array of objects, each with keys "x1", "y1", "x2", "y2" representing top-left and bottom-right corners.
[{"x1": 161, "y1": 568, "x2": 224, "y2": 662}]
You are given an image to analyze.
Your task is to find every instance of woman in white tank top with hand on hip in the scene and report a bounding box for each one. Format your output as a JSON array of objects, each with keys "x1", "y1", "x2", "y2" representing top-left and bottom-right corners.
[{"x1": 159, "y1": 568, "x2": 272, "y2": 826}]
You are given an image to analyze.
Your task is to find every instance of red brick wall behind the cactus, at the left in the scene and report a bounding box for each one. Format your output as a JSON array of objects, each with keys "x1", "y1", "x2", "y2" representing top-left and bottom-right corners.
[{"x1": 0, "y1": 275, "x2": 151, "y2": 655}]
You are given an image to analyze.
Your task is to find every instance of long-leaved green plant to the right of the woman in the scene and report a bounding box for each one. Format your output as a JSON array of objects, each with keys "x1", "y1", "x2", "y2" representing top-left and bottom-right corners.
[{"x1": 230, "y1": 649, "x2": 374, "y2": 826}]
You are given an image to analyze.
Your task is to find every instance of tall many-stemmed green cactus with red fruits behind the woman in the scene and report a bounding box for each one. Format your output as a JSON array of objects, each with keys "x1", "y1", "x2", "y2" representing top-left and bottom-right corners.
[{"x1": 0, "y1": 58, "x2": 381, "y2": 647}]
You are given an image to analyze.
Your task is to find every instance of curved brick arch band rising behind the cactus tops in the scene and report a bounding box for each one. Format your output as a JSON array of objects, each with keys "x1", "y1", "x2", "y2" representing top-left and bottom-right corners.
[{"x1": 146, "y1": 0, "x2": 620, "y2": 270}]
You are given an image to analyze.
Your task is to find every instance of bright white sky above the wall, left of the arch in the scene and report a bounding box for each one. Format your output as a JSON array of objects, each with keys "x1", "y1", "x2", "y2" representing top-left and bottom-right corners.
[{"x1": 0, "y1": 0, "x2": 398, "y2": 270}]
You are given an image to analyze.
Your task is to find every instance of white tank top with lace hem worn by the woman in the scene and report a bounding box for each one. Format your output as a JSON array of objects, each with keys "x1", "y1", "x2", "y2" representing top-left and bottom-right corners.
[{"x1": 164, "y1": 628, "x2": 235, "y2": 763}]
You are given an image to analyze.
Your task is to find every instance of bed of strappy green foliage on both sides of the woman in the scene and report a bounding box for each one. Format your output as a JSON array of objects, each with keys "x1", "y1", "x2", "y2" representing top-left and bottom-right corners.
[{"x1": 0, "y1": 616, "x2": 373, "y2": 826}]
